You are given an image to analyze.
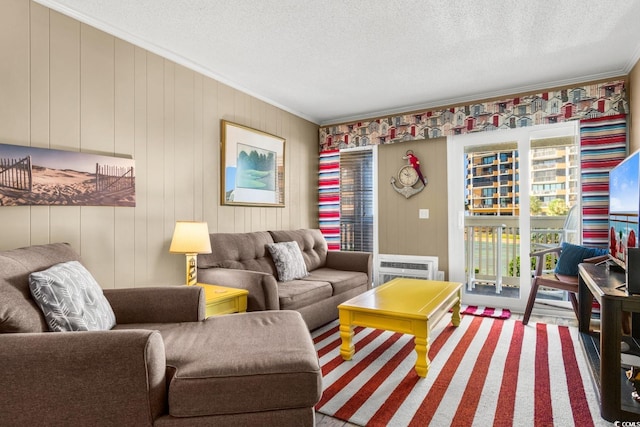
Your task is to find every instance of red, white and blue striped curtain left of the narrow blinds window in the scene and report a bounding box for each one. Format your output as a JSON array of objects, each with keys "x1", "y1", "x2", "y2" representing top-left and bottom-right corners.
[{"x1": 318, "y1": 150, "x2": 340, "y2": 251}]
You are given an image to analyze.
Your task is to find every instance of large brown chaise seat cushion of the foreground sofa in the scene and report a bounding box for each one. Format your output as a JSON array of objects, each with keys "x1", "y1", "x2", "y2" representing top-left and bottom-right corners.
[{"x1": 138, "y1": 311, "x2": 322, "y2": 417}]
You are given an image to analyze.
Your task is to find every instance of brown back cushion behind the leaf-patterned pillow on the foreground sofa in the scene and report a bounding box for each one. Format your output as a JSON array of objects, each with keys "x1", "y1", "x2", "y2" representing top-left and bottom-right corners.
[{"x1": 0, "y1": 243, "x2": 80, "y2": 333}]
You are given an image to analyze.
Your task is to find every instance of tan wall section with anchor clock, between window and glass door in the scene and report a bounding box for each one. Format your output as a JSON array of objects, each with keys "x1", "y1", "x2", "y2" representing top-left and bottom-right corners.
[{"x1": 378, "y1": 138, "x2": 449, "y2": 277}]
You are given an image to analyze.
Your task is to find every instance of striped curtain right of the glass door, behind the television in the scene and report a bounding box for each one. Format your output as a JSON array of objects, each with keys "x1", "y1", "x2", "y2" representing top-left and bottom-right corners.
[{"x1": 580, "y1": 114, "x2": 627, "y2": 247}]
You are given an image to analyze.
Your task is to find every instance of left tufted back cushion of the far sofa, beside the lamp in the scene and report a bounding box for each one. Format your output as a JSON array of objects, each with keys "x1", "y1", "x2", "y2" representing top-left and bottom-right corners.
[{"x1": 198, "y1": 231, "x2": 276, "y2": 276}]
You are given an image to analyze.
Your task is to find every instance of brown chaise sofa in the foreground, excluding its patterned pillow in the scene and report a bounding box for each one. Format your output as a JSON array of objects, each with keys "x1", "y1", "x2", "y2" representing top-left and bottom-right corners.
[{"x1": 0, "y1": 244, "x2": 321, "y2": 426}]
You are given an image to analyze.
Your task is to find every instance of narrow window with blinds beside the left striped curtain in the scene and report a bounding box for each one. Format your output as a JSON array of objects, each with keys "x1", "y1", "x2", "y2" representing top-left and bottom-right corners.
[{"x1": 340, "y1": 150, "x2": 374, "y2": 252}]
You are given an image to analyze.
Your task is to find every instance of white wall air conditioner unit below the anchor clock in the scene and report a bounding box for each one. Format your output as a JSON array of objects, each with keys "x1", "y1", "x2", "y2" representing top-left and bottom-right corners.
[{"x1": 375, "y1": 254, "x2": 444, "y2": 286}]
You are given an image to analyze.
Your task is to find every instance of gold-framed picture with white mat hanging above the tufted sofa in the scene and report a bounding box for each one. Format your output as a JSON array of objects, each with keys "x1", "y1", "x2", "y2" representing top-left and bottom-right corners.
[{"x1": 220, "y1": 120, "x2": 285, "y2": 207}]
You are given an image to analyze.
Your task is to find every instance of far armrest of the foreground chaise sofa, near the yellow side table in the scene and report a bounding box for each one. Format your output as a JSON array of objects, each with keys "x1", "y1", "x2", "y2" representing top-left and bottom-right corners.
[{"x1": 104, "y1": 286, "x2": 206, "y2": 324}]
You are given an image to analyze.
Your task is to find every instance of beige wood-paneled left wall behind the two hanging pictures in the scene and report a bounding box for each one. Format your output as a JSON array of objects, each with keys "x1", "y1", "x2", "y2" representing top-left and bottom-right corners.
[{"x1": 0, "y1": 0, "x2": 318, "y2": 288}]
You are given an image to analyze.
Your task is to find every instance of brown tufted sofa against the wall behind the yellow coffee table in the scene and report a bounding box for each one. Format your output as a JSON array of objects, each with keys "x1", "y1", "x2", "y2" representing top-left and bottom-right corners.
[{"x1": 198, "y1": 229, "x2": 373, "y2": 330}]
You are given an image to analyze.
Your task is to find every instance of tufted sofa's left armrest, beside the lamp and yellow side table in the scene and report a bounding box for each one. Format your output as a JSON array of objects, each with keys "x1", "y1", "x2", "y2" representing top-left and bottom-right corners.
[{"x1": 198, "y1": 267, "x2": 280, "y2": 311}]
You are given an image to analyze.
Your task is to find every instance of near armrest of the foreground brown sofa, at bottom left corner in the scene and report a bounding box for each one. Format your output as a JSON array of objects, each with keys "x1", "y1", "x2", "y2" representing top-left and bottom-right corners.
[{"x1": 0, "y1": 330, "x2": 167, "y2": 426}]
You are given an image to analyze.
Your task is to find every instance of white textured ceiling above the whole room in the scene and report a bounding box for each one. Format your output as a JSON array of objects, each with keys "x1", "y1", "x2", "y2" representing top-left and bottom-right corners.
[{"x1": 36, "y1": 0, "x2": 640, "y2": 124}]
